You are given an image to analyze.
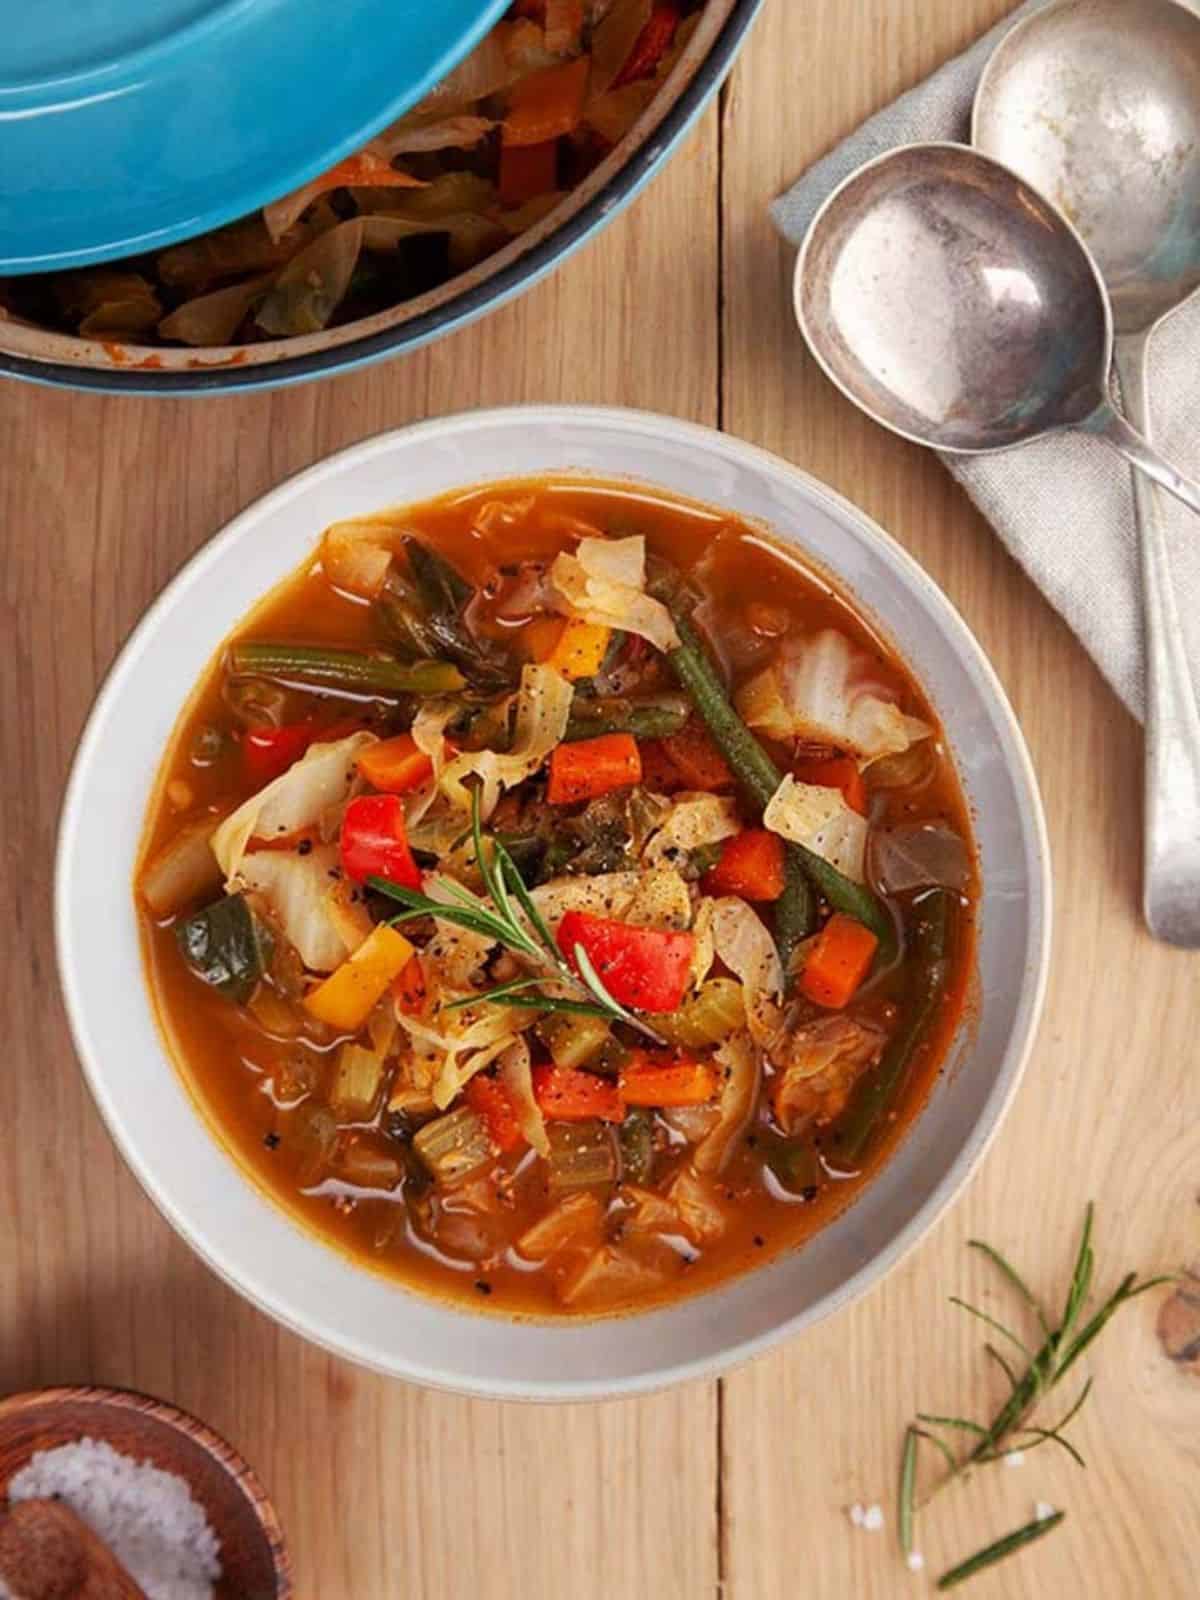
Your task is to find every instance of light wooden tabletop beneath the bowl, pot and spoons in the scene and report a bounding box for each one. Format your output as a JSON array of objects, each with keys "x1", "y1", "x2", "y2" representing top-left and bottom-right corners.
[{"x1": 0, "y1": 0, "x2": 1200, "y2": 1600}]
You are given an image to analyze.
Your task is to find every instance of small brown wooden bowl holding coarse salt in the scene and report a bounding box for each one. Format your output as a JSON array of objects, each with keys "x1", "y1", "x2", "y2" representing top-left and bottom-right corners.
[{"x1": 0, "y1": 1387, "x2": 291, "y2": 1600}]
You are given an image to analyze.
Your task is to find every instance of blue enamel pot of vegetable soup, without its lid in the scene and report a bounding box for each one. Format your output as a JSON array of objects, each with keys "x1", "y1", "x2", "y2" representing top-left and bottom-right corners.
[{"x1": 0, "y1": 0, "x2": 762, "y2": 394}]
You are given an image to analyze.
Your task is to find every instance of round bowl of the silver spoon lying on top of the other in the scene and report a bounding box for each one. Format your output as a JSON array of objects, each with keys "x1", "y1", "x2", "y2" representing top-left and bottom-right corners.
[{"x1": 795, "y1": 144, "x2": 1112, "y2": 454}]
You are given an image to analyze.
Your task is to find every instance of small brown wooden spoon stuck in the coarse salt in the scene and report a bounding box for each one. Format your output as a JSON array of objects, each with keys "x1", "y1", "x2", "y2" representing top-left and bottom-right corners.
[{"x1": 0, "y1": 1499, "x2": 146, "y2": 1600}]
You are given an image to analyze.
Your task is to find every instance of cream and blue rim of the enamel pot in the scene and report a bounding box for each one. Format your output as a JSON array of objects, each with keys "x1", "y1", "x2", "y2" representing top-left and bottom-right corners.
[{"x1": 0, "y1": 0, "x2": 763, "y2": 394}]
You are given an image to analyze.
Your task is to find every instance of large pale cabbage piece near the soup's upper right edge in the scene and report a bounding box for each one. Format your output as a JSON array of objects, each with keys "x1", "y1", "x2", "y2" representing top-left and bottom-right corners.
[{"x1": 736, "y1": 627, "x2": 933, "y2": 762}]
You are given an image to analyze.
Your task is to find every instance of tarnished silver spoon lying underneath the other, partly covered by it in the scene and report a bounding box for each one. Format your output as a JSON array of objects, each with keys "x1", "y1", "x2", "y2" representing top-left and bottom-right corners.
[{"x1": 973, "y1": 0, "x2": 1200, "y2": 949}]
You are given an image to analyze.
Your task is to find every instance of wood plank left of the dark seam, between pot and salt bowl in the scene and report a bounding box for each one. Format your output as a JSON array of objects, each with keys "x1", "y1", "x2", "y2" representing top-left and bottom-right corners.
[{"x1": 0, "y1": 112, "x2": 717, "y2": 1600}]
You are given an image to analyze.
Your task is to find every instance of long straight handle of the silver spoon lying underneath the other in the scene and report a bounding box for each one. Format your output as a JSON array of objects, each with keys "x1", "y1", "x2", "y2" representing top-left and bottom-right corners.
[{"x1": 1117, "y1": 334, "x2": 1200, "y2": 949}]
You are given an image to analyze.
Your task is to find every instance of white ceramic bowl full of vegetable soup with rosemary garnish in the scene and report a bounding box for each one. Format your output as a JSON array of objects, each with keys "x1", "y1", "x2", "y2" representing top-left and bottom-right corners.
[{"x1": 56, "y1": 408, "x2": 1050, "y2": 1398}]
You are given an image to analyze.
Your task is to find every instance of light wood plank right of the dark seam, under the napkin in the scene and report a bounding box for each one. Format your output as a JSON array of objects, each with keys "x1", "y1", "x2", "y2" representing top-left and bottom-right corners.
[{"x1": 723, "y1": 0, "x2": 1200, "y2": 1600}]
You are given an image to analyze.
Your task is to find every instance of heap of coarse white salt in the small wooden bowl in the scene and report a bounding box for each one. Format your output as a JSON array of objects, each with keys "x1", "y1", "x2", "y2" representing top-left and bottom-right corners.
[{"x1": 8, "y1": 1438, "x2": 221, "y2": 1600}]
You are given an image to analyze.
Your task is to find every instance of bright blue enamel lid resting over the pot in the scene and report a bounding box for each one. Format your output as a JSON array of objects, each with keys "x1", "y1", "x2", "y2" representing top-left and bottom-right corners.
[{"x1": 0, "y1": 0, "x2": 509, "y2": 274}]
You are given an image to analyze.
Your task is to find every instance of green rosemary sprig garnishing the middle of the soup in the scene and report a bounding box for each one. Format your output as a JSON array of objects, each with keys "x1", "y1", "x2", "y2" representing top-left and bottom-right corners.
[{"x1": 366, "y1": 789, "x2": 664, "y2": 1045}]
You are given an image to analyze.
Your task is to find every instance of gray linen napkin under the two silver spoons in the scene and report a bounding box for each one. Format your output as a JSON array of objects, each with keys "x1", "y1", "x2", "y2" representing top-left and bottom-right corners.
[{"x1": 771, "y1": 0, "x2": 1200, "y2": 717}]
